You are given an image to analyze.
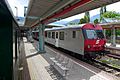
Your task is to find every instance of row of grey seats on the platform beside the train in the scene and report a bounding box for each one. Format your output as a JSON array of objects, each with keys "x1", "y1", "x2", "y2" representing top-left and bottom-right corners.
[{"x1": 50, "y1": 55, "x2": 69, "y2": 77}]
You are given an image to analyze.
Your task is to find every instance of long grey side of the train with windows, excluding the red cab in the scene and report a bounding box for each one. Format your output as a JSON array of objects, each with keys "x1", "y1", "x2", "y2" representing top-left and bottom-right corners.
[{"x1": 45, "y1": 26, "x2": 84, "y2": 55}]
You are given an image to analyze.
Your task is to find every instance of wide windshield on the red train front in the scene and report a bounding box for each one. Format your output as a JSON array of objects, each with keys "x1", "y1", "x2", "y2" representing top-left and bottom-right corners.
[{"x1": 84, "y1": 30, "x2": 104, "y2": 39}]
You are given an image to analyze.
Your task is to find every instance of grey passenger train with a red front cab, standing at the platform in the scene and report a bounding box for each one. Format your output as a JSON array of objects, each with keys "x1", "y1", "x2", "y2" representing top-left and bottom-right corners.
[{"x1": 33, "y1": 23, "x2": 106, "y2": 58}]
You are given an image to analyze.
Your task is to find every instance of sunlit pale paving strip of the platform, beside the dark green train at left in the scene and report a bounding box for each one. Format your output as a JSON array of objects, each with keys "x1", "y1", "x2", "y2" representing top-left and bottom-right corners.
[{"x1": 23, "y1": 38, "x2": 53, "y2": 80}]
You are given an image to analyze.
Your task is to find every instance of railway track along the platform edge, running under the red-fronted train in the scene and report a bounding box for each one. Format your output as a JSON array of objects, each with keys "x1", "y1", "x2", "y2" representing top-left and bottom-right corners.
[{"x1": 46, "y1": 45, "x2": 120, "y2": 77}]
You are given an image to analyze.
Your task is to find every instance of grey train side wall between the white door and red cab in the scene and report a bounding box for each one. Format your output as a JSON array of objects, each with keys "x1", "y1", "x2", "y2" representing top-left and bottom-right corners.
[{"x1": 59, "y1": 29, "x2": 84, "y2": 55}]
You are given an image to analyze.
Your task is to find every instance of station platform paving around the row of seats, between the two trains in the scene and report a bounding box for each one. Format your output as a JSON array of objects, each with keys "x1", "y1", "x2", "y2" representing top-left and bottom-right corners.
[{"x1": 20, "y1": 38, "x2": 120, "y2": 80}]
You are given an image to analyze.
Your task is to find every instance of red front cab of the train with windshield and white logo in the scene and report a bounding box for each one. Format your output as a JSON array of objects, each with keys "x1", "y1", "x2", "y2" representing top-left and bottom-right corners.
[{"x1": 82, "y1": 24, "x2": 106, "y2": 57}]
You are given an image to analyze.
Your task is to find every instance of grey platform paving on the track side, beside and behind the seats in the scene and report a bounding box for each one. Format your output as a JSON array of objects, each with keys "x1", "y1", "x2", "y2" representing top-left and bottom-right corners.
[{"x1": 34, "y1": 41, "x2": 120, "y2": 80}]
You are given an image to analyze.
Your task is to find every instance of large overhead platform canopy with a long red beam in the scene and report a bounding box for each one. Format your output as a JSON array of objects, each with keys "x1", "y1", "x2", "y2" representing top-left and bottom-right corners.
[{"x1": 24, "y1": 0, "x2": 119, "y2": 27}]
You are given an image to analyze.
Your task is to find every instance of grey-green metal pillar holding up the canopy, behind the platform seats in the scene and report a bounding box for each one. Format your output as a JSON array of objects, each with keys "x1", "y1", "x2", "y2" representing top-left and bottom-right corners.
[{"x1": 39, "y1": 24, "x2": 45, "y2": 53}]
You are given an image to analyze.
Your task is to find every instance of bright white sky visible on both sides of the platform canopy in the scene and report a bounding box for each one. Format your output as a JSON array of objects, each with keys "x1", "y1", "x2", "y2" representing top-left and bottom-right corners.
[{"x1": 8, "y1": 0, "x2": 120, "y2": 21}]
